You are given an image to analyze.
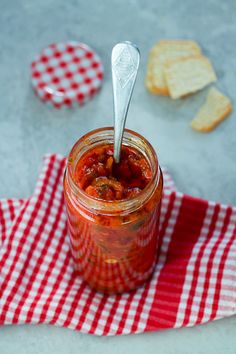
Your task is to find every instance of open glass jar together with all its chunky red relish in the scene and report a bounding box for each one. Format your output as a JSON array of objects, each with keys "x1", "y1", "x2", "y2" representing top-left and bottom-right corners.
[{"x1": 64, "y1": 128, "x2": 163, "y2": 294}]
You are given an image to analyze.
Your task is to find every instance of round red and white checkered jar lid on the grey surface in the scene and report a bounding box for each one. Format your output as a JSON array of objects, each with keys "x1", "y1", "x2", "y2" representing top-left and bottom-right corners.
[{"x1": 31, "y1": 41, "x2": 103, "y2": 108}]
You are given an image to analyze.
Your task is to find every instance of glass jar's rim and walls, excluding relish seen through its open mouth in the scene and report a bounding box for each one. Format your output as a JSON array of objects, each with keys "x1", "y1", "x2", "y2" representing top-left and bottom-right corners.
[{"x1": 64, "y1": 128, "x2": 163, "y2": 294}]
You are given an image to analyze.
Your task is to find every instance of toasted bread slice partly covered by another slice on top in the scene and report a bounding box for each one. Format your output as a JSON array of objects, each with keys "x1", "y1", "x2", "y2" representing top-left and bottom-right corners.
[{"x1": 145, "y1": 39, "x2": 201, "y2": 95}]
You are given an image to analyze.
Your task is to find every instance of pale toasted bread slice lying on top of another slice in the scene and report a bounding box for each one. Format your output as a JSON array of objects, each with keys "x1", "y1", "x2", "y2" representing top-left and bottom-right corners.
[{"x1": 164, "y1": 55, "x2": 217, "y2": 99}]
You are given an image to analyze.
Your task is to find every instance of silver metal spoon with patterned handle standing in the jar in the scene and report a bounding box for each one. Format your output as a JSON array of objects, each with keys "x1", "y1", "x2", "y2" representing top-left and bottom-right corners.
[{"x1": 111, "y1": 42, "x2": 140, "y2": 163}]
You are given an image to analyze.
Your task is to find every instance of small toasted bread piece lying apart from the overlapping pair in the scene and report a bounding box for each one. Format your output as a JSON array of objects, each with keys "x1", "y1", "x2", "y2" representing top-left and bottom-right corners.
[{"x1": 191, "y1": 87, "x2": 233, "y2": 132}]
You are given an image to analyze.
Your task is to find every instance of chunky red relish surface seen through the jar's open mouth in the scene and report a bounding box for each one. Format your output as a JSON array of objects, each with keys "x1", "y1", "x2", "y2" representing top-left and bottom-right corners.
[{"x1": 75, "y1": 145, "x2": 152, "y2": 201}]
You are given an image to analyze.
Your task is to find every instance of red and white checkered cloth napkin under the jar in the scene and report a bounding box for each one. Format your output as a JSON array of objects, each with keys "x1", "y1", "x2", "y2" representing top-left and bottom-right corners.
[{"x1": 0, "y1": 155, "x2": 236, "y2": 335}]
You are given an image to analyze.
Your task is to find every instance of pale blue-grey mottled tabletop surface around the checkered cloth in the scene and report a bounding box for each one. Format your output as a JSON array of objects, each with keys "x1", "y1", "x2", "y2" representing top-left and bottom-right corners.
[{"x1": 0, "y1": 0, "x2": 236, "y2": 354}]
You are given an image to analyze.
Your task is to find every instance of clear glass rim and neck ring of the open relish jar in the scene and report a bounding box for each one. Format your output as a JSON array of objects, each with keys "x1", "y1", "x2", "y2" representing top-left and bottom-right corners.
[{"x1": 65, "y1": 127, "x2": 160, "y2": 215}]
